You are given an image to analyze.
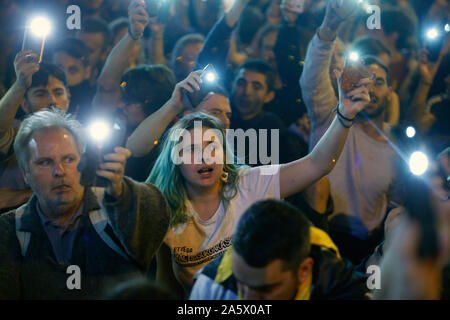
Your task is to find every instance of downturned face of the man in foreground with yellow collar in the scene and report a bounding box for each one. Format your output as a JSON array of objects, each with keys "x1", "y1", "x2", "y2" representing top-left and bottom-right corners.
[{"x1": 231, "y1": 250, "x2": 299, "y2": 300}]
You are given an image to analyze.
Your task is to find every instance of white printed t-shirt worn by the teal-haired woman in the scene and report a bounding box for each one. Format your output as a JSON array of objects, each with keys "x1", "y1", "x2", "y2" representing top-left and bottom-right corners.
[{"x1": 164, "y1": 165, "x2": 280, "y2": 286}]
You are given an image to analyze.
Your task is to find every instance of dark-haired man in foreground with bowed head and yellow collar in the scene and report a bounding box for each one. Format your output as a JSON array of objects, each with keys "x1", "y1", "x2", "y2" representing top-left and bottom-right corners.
[{"x1": 190, "y1": 200, "x2": 368, "y2": 300}]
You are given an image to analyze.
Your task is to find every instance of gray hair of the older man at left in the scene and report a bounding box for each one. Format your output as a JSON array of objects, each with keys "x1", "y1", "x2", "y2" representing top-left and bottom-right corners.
[{"x1": 14, "y1": 108, "x2": 85, "y2": 171}]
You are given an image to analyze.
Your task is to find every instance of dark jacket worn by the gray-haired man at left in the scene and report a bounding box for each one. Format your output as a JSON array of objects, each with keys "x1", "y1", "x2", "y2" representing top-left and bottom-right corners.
[{"x1": 0, "y1": 178, "x2": 170, "y2": 299}]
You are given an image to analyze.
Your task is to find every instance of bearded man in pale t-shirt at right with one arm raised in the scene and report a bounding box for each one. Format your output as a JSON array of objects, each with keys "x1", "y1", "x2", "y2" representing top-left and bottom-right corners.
[{"x1": 300, "y1": 0, "x2": 398, "y2": 263}]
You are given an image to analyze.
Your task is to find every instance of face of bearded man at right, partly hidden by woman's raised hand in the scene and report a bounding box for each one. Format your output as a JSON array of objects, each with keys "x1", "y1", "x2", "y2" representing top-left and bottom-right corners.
[{"x1": 361, "y1": 64, "x2": 389, "y2": 118}]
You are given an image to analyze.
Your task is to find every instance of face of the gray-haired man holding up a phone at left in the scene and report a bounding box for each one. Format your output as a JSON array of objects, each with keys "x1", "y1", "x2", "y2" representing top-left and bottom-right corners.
[{"x1": 24, "y1": 127, "x2": 84, "y2": 213}]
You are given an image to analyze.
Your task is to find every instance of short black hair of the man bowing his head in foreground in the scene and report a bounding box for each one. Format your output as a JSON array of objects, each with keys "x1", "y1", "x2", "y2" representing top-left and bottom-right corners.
[{"x1": 233, "y1": 199, "x2": 311, "y2": 269}]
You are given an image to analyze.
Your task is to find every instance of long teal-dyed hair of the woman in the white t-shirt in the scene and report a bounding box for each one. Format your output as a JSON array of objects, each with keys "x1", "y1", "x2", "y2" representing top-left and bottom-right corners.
[{"x1": 147, "y1": 112, "x2": 247, "y2": 226}]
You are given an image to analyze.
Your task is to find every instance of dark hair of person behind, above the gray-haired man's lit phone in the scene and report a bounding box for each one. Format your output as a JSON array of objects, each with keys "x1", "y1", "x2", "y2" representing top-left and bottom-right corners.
[{"x1": 120, "y1": 65, "x2": 176, "y2": 116}]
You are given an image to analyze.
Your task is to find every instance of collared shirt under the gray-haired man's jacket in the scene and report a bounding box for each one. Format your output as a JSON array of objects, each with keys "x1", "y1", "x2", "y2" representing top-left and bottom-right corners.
[{"x1": 36, "y1": 201, "x2": 83, "y2": 265}]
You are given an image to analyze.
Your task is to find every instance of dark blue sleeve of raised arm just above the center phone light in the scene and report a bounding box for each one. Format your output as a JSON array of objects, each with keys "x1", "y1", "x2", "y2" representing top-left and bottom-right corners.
[{"x1": 194, "y1": 15, "x2": 234, "y2": 78}]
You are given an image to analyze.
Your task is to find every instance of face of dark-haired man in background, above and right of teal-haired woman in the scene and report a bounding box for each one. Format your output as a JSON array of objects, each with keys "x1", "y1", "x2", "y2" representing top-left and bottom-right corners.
[{"x1": 233, "y1": 69, "x2": 275, "y2": 119}]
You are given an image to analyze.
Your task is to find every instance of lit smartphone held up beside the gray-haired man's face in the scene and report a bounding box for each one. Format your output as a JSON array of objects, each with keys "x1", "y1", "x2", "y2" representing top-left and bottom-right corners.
[{"x1": 77, "y1": 118, "x2": 126, "y2": 188}]
